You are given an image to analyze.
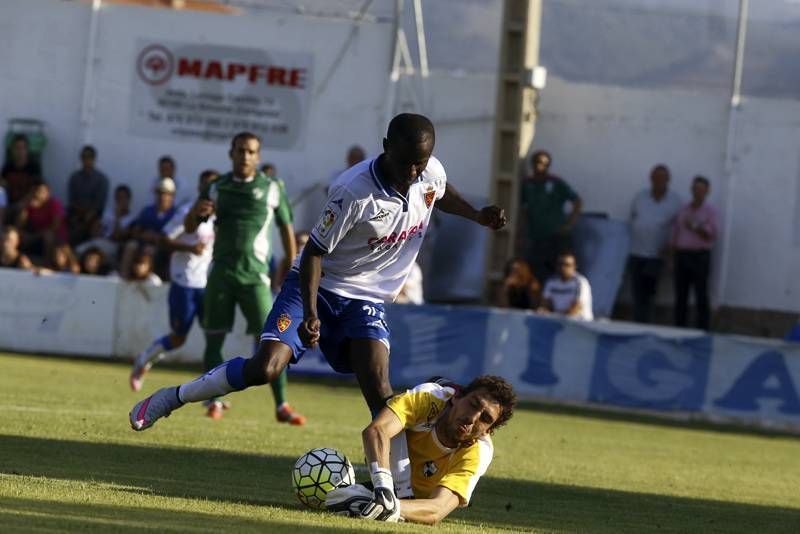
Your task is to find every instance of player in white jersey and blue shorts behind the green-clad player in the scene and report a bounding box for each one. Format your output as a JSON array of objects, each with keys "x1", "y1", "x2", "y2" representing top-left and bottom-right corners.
[{"x1": 130, "y1": 170, "x2": 218, "y2": 391}]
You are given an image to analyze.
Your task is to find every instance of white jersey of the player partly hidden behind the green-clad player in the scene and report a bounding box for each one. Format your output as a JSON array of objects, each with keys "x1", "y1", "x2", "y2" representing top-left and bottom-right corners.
[{"x1": 164, "y1": 203, "x2": 214, "y2": 288}]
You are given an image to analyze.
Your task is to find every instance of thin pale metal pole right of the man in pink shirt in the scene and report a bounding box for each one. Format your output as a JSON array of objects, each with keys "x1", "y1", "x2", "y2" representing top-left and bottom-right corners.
[{"x1": 717, "y1": 0, "x2": 749, "y2": 310}]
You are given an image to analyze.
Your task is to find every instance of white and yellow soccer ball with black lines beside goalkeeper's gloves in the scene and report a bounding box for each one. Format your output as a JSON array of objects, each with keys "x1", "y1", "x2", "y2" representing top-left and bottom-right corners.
[{"x1": 292, "y1": 448, "x2": 356, "y2": 508}]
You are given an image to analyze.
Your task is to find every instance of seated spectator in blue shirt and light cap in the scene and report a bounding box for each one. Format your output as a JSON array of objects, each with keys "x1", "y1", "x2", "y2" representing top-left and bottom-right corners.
[{"x1": 120, "y1": 178, "x2": 175, "y2": 278}]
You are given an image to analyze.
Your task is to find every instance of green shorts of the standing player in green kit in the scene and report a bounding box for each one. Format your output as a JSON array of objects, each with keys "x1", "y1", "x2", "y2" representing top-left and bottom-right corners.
[{"x1": 203, "y1": 271, "x2": 272, "y2": 335}]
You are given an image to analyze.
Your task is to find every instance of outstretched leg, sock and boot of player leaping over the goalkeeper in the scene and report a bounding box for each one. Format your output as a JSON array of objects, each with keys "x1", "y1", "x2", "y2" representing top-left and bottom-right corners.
[{"x1": 129, "y1": 340, "x2": 292, "y2": 431}]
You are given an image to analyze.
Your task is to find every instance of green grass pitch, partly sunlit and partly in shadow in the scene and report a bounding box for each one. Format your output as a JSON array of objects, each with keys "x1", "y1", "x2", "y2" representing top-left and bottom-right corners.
[{"x1": 0, "y1": 355, "x2": 800, "y2": 533}]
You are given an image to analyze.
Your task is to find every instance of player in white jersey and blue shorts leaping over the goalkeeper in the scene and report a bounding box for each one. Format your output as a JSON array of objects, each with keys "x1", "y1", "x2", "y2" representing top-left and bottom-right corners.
[{"x1": 129, "y1": 113, "x2": 506, "y2": 519}]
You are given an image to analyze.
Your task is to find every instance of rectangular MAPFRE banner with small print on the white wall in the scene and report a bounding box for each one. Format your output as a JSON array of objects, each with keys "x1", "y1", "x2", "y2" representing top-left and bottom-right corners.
[{"x1": 130, "y1": 40, "x2": 313, "y2": 149}]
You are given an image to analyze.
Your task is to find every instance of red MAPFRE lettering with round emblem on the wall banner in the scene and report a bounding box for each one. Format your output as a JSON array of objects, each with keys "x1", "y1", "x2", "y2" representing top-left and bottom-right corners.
[{"x1": 136, "y1": 44, "x2": 307, "y2": 89}]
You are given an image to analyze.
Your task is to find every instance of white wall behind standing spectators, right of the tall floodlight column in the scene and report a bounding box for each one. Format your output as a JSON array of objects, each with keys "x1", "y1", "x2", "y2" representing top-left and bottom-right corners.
[{"x1": 532, "y1": 77, "x2": 800, "y2": 311}]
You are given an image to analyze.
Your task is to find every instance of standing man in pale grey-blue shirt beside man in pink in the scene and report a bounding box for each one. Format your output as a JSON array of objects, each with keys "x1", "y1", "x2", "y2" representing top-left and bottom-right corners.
[{"x1": 628, "y1": 165, "x2": 683, "y2": 323}]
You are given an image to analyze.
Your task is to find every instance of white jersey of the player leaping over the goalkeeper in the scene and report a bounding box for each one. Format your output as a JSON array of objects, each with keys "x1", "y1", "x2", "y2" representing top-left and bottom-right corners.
[{"x1": 302, "y1": 157, "x2": 447, "y2": 302}]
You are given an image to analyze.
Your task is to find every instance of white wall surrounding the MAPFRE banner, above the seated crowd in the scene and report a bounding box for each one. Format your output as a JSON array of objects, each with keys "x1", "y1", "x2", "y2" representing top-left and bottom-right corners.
[{"x1": 0, "y1": 0, "x2": 392, "y2": 221}]
